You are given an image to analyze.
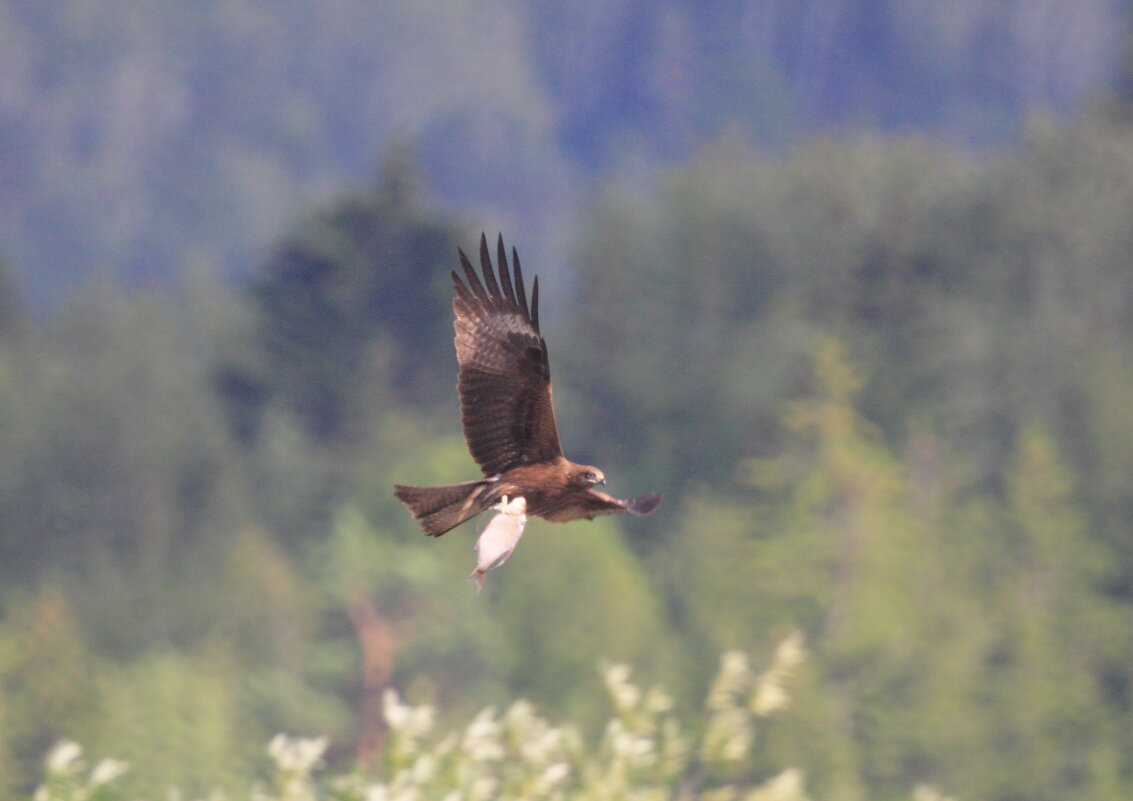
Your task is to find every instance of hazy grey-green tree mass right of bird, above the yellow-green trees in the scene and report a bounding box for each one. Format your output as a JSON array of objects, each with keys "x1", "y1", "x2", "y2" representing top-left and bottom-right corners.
[{"x1": 566, "y1": 117, "x2": 1133, "y2": 539}]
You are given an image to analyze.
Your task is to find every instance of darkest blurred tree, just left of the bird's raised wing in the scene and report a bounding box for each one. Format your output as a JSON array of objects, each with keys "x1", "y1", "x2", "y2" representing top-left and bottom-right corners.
[{"x1": 245, "y1": 156, "x2": 458, "y2": 440}]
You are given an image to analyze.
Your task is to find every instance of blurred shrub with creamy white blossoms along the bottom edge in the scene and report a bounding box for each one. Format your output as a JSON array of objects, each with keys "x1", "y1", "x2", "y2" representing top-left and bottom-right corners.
[{"x1": 28, "y1": 634, "x2": 937, "y2": 801}]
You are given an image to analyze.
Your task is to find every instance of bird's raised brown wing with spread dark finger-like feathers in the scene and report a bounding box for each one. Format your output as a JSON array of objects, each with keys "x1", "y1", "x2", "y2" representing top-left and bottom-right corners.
[{"x1": 452, "y1": 233, "x2": 562, "y2": 476}]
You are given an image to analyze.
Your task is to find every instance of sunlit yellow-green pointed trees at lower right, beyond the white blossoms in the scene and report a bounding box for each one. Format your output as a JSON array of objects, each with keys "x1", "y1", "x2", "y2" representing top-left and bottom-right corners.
[{"x1": 650, "y1": 341, "x2": 1131, "y2": 799}]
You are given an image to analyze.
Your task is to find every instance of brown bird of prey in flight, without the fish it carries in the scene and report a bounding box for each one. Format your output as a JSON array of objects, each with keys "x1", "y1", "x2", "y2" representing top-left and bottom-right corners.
[{"x1": 393, "y1": 233, "x2": 661, "y2": 537}]
